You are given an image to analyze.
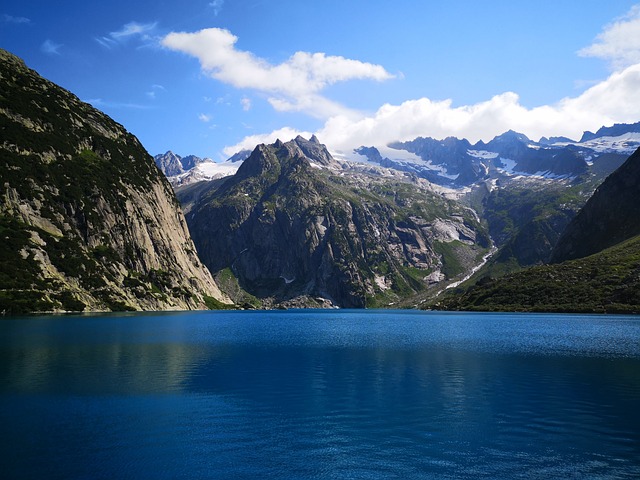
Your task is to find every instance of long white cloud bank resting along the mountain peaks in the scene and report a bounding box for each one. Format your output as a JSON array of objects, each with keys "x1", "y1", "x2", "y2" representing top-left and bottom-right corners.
[{"x1": 225, "y1": 64, "x2": 640, "y2": 155}]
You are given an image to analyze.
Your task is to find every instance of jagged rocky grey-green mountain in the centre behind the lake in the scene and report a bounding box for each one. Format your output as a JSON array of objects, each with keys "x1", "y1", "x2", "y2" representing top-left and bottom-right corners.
[{"x1": 179, "y1": 137, "x2": 490, "y2": 307}]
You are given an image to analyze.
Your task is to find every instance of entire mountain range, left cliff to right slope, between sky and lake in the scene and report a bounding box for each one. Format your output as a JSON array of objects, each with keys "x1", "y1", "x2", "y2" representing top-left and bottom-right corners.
[{"x1": 0, "y1": 47, "x2": 640, "y2": 314}]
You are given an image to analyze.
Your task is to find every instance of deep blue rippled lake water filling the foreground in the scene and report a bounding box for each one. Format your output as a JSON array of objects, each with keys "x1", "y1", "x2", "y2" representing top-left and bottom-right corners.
[{"x1": 0, "y1": 310, "x2": 640, "y2": 479}]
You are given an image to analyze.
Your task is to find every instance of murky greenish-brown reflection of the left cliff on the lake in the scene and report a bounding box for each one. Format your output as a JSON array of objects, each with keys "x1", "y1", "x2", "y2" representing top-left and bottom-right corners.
[{"x1": 0, "y1": 344, "x2": 218, "y2": 395}]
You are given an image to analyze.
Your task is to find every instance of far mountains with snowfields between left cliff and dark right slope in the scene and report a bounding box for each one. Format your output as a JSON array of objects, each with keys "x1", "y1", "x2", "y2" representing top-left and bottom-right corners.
[{"x1": 156, "y1": 119, "x2": 640, "y2": 308}]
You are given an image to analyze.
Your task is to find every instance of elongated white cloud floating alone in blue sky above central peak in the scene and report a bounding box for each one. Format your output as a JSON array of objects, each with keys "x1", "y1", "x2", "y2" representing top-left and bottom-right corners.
[{"x1": 162, "y1": 28, "x2": 393, "y2": 118}]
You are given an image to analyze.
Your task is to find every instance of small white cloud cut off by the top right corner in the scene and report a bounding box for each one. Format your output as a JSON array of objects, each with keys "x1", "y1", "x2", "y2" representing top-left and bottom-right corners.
[{"x1": 578, "y1": 5, "x2": 640, "y2": 69}]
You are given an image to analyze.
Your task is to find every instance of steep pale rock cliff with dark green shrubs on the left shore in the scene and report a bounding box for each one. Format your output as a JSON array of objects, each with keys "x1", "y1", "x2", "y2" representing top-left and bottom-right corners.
[{"x1": 0, "y1": 50, "x2": 229, "y2": 314}]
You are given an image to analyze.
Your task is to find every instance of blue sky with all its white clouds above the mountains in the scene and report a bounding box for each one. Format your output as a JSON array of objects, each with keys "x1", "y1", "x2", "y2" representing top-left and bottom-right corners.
[{"x1": 0, "y1": 0, "x2": 640, "y2": 160}]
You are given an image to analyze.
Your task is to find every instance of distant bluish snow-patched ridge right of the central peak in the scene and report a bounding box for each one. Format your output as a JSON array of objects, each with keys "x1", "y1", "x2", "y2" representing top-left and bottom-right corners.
[{"x1": 355, "y1": 124, "x2": 640, "y2": 188}]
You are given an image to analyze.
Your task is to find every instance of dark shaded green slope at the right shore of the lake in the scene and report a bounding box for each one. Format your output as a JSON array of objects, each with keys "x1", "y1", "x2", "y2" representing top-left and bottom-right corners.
[{"x1": 431, "y1": 149, "x2": 640, "y2": 313}]
